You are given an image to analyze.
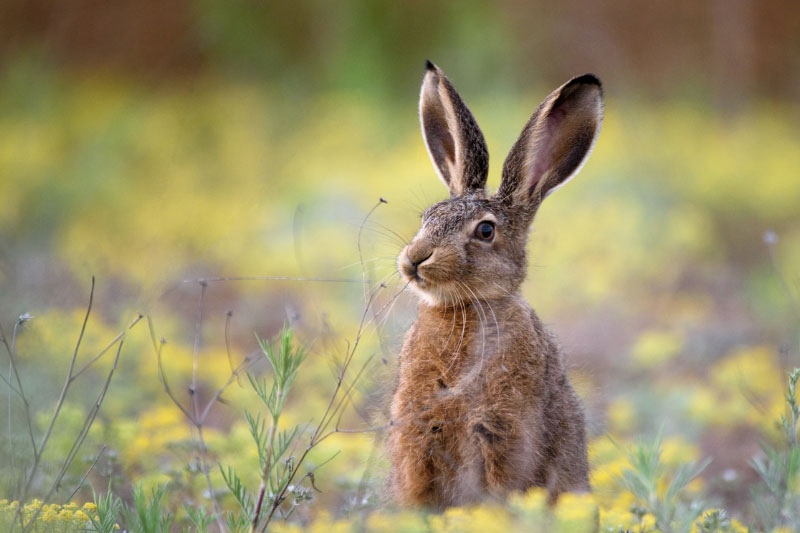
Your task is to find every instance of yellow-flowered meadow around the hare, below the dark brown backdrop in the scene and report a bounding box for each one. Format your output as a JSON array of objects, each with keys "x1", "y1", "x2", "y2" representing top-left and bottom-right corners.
[{"x1": 0, "y1": 63, "x2": 800, "y2": 532}]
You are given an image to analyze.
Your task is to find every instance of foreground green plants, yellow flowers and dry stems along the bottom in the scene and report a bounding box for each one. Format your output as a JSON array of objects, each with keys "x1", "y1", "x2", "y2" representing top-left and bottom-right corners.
[{"x1": 0, "y1": 284, "x2": 800, "y2": 533}]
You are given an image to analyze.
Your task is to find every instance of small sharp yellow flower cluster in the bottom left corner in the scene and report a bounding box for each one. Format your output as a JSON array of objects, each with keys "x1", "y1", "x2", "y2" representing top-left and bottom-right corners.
[{"x1": 0, "y1": 500, "x2": 114, "y2": 533}]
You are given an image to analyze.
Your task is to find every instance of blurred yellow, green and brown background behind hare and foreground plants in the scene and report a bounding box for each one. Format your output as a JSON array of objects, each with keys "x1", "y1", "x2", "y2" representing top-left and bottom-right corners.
[{"x1": 0, "y1": 0, "x2": 800, "y2": 519}]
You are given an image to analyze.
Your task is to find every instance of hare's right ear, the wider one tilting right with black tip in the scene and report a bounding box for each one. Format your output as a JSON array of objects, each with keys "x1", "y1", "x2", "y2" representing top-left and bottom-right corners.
[{"x1": 497, "y1": 74, "x2": 603, "y2": 209}]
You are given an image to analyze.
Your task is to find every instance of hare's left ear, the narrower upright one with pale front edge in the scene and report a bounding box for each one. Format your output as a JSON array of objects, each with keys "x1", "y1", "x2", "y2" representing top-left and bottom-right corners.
[{"x1": 419, "y1": 61, "x2": 489, "y2": 197}]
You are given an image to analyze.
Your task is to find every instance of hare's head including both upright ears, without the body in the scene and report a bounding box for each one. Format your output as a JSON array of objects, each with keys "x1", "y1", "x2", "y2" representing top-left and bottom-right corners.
[{"x1": 398, "y1": 62, "x2": 603, "y2": 305}]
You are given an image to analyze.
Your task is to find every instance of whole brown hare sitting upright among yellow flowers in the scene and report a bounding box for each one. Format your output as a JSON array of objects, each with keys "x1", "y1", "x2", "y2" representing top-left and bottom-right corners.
[{"x1": 388, "y1": 61, "x2": 603, "y2": 509}]
